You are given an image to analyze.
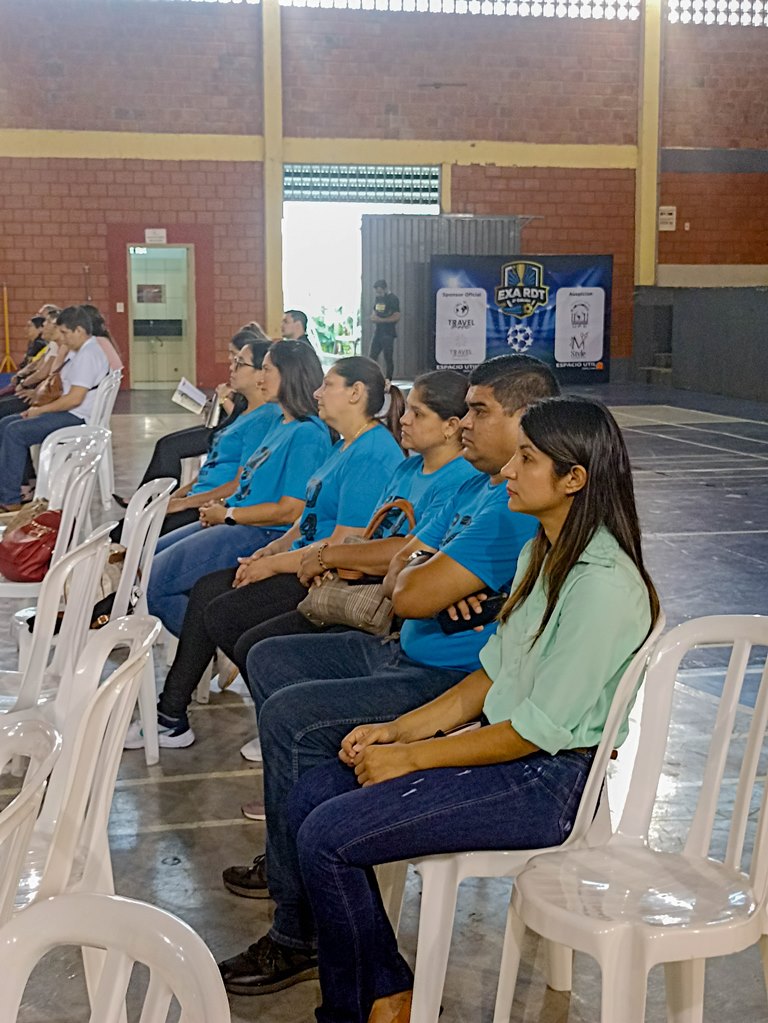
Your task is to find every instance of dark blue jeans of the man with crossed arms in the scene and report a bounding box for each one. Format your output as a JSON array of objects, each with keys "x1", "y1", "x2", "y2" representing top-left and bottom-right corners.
[{"x1": 247, "y1": 630, "x2": 466, "y2": 948}]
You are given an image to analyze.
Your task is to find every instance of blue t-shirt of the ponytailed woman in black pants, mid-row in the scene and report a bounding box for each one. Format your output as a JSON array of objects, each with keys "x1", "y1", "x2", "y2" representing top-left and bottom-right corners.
[{"x1": 291, "y1": 426, "x2": 404, "y2": 550}]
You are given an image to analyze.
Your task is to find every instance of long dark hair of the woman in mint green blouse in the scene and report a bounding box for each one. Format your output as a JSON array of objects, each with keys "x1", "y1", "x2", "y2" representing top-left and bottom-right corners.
[{"x1": 499, "y1": 397, "x2": 660, "y2": 647}]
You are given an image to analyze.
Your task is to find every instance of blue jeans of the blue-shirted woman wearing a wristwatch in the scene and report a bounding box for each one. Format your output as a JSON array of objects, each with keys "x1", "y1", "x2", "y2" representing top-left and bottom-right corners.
[{"x1": 146, "y1": 522, "x2": 282, "y2": 636}]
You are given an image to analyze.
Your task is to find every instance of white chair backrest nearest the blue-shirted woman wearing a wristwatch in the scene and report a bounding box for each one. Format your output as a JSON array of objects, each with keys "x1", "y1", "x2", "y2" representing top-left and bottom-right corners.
[{"x1": 112, "y1": 478, "x2": 176, "y2": 618}]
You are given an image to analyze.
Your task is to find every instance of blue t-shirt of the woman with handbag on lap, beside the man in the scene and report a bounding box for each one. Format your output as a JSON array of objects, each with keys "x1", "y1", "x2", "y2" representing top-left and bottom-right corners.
[{"x1": 376, "y1": 454, "x2": 480, "y2": 536}]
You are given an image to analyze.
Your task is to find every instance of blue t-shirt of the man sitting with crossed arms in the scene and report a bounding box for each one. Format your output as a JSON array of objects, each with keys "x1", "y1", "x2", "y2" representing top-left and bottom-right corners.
[{"x1": 400, "y1": 473, "x2": 539, "y2": 672}]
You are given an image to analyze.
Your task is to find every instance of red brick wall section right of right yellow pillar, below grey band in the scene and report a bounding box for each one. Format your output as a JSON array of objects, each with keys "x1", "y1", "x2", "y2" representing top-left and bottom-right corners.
[{"x1": 659, "y1": 174, "x2": 768, "y2": 265}]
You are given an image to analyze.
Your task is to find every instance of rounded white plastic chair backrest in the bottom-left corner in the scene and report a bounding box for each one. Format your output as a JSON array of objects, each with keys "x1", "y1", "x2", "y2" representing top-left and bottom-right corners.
[{"x1": 0, "y1": 892, "x2": 230, "y2": 1023}]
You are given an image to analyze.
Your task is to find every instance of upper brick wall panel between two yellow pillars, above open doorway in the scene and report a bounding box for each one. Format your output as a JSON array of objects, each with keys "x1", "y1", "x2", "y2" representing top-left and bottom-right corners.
[{"x1": 282, "y1": 8, "x2": 640, "y2": 143}]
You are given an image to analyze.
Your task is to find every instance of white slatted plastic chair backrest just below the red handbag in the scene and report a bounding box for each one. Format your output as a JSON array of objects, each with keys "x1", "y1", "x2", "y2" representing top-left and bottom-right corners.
[{"x1": 13, "y1": 523, "x2": 114, "y2": 724}]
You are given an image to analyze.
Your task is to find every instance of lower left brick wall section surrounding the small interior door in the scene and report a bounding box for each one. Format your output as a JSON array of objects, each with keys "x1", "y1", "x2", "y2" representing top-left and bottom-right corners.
[{"x1": 0, "y1": 159, "x2": 264, "y2": 385}]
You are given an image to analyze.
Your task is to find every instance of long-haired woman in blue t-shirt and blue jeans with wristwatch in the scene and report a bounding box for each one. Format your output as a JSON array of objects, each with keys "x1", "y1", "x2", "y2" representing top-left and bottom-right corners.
[{"x1": 147, "y1": 341, "x2": 331, "y2": 635}]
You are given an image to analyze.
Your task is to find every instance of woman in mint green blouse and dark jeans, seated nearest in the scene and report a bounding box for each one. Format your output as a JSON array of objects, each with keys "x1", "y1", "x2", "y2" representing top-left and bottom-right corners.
[{"x1": 288, "y1": 398, "x2": 659, "y2": 1023}]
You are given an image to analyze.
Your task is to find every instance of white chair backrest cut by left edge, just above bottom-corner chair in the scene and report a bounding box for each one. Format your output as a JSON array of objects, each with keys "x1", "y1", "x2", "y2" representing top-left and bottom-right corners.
[{"x1": 0, "y1": 719, "x2": 61, "y2": 925}]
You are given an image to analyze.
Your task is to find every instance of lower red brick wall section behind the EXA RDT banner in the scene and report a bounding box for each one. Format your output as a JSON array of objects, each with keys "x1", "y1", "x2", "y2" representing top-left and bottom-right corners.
[{"x1": 452, "y1": 166, "x2": 635, "y2": 357}]
